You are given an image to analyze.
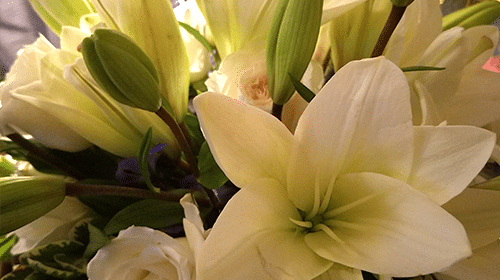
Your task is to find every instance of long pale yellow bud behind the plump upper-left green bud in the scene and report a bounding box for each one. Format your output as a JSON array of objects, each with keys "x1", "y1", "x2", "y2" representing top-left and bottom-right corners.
[{"x1": 93, "y1": 0, "x2": 190, "y2": 122}]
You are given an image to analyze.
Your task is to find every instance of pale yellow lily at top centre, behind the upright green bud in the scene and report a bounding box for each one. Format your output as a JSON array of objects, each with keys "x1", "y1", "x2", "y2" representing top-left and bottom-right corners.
[{"x1": 196, "y1": 0, "x2": 365, "y2": 59}]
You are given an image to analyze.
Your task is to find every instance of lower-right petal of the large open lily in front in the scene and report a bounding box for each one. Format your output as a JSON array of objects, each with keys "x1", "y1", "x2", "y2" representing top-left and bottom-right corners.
[{"x1": 305, "y1": 173, "x2": 471, "y2": 277}]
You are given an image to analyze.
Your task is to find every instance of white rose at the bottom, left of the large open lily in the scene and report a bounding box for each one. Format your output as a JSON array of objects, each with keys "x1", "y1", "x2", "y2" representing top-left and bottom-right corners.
[{"x1": 87, "y1": 194, "x2": 208, "y2": 280}]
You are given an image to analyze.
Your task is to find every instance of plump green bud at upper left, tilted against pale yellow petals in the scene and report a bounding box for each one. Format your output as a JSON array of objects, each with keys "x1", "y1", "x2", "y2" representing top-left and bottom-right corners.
[{"x1": 82, "y1": 29, "x2": 161, "y2": 112}]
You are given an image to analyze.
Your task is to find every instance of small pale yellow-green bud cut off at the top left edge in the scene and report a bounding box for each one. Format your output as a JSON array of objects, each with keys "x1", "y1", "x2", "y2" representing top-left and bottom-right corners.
[{"x1": 29, "y1": 0, "x2": 96, "y2": 35}]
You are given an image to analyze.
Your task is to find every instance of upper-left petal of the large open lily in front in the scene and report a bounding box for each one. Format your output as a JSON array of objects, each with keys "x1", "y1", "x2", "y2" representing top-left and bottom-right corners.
[{"x1": 194, "y1": 92, "x2": 293, "y2": 188}]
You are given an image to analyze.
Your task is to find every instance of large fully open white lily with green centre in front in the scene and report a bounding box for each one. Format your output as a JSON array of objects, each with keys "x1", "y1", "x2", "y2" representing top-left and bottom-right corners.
[{"x1": 195, "y1": 57, "x2": 495, "y2": 279}]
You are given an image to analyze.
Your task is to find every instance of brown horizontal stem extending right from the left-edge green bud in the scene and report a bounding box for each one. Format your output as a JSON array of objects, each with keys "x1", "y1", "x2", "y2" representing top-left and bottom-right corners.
[{"x1": 66, "y1": 183, "x2": 211, "y2": 207}]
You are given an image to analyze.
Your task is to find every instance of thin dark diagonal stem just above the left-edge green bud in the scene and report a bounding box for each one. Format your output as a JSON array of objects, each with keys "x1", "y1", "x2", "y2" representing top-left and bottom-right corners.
[{"x1": 7, "y1": 133, "x2": 84, "y2": 180}]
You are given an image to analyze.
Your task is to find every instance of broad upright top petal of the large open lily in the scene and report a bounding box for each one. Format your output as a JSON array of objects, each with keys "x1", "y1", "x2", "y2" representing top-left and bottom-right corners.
[{"x1": 287, "y1": 57, "x2": 413, "y2": 212}]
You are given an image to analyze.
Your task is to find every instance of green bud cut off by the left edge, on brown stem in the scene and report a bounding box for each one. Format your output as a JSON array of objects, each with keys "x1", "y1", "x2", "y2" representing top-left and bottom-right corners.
[{"x1": 0, "y1": 176, "x2": 66, "y2": 235}]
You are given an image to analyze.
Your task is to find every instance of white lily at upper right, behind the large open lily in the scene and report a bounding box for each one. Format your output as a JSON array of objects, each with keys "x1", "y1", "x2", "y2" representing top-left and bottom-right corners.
[{"x1": 384, "y1": 0, "x2": 500, "y2": 126}]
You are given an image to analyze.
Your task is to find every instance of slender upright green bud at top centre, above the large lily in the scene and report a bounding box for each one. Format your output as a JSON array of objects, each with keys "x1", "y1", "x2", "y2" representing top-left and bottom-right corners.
[{"x1": 267, "y1": 0, "x2": 323, "y2": 105}]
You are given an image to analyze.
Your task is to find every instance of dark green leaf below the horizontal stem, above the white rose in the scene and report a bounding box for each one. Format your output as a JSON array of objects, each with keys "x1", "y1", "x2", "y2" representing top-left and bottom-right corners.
[{"x1": 104, "y1": 199, "x2": 184, "y2": 235}]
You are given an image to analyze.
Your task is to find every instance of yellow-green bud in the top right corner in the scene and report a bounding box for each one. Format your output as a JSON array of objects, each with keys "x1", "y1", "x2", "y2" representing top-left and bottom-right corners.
[{"x1": 443, "y1": 1, "x2": 500, "y2": 31}]
